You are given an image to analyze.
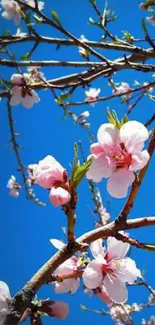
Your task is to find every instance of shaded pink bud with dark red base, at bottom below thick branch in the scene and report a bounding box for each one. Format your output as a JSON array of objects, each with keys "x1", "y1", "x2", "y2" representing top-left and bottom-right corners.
[{"x1": 40, "y1": 300, "x2": 69, "y2": 319}]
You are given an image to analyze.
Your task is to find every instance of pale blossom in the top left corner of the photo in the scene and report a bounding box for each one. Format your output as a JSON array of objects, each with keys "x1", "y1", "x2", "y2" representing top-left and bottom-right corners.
[{"x1": 0, "y1": 0, "x2": 21, "y2": 25}]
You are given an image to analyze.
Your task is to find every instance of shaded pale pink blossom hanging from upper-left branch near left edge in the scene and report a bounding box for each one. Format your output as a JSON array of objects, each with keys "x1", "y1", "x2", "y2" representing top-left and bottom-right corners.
[{"x1": 10, "y1": 73, "x2": 40, "y2": 108}]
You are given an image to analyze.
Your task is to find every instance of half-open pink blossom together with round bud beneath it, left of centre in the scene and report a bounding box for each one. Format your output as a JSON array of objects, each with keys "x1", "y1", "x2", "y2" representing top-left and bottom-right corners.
[{"x1": 28, "y1": 155, "x2": 71, "y2": 207}]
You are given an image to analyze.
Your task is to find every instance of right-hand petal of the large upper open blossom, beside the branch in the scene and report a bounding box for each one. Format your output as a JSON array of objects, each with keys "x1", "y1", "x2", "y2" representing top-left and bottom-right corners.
[{"x1": 129, "y1": 150, "x2": 150, "y2": 171}]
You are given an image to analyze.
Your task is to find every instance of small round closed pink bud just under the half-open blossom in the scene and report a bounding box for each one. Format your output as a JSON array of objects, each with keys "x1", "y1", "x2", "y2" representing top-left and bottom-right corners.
[{"x1": 49, "y1": 187, "x2": 71, "y2": 207}]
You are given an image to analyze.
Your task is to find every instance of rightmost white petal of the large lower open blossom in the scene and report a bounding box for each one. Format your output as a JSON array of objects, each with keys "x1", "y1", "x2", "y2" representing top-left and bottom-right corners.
[{"x1": 120, "y1": 257, "x2": 141, "y2": 284}]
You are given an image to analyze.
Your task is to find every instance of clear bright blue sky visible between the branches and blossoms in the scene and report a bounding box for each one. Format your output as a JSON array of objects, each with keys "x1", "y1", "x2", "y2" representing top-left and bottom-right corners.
[{"x1": 0, "y1": 0, "x2": 155, "y2": 325}]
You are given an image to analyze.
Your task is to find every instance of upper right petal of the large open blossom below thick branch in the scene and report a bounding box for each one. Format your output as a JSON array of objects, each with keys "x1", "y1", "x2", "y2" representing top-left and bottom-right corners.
[{"x1": 107, "y1": 237, "x2": 130, "y2": 260}]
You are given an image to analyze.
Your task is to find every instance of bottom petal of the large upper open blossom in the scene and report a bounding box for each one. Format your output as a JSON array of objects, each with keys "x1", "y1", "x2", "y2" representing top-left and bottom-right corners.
[{"x1": 107, "y1": 168, "x2": 135, "y2": 199}]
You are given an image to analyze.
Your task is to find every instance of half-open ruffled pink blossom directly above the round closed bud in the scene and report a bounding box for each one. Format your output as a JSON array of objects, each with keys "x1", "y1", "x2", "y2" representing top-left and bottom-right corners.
[{"x1": 30, "y1": 155, "x2": 67, "y2": 189}]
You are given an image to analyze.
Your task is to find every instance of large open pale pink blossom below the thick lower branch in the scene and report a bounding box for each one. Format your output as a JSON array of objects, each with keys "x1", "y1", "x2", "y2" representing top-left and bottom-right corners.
[{"x1": 83, "y1": 237, "x2": 141, "y2": 303}]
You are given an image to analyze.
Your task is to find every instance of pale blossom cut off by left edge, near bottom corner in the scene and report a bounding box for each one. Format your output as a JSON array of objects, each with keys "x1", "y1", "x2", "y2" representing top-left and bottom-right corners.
[{"x1": 0, "y1": 281, "x2": 11, "y2": 324}]
